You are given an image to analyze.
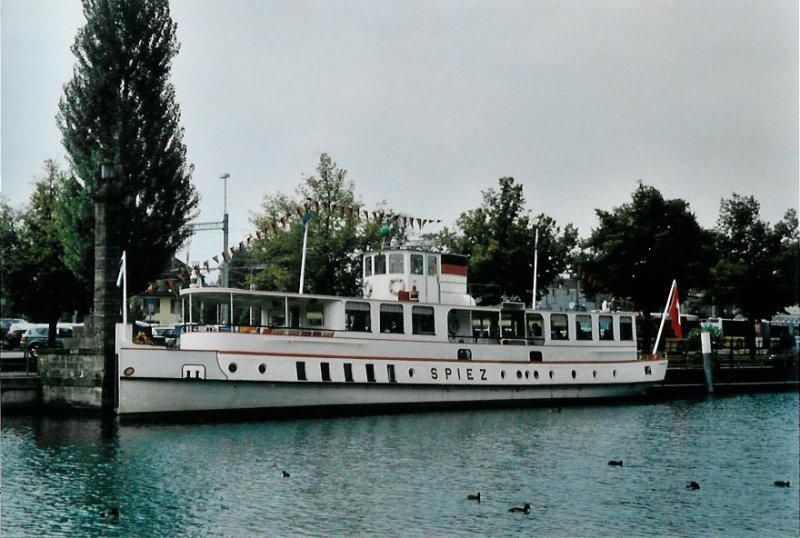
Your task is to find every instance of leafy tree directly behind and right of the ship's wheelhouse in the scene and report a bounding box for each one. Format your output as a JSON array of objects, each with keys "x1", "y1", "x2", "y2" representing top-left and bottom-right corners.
[{"x1": 438, "y1": 177, "x2": 578, "y2": 304}]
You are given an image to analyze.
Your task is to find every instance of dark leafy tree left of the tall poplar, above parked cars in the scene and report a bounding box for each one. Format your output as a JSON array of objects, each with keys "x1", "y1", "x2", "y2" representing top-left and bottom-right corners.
[{"x1": 2, "y1": 160, "x2": 91, "y2": 345}]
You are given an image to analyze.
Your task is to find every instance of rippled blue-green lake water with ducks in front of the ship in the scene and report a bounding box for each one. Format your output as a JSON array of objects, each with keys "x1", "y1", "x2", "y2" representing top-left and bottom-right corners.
[{"x1": 0, "y1": 393, "x2": 800, "y2": 537}]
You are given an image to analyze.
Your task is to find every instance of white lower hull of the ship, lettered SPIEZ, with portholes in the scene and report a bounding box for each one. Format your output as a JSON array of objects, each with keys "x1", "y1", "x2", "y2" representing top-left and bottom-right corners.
[{"x1": 117, "y1": 347, "x2": 666, "y2": 416}]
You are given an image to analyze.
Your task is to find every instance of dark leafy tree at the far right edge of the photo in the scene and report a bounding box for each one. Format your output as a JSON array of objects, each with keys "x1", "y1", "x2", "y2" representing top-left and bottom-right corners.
[{"x1": 711, "y1": 193, "x2": 798, "y2": 319}]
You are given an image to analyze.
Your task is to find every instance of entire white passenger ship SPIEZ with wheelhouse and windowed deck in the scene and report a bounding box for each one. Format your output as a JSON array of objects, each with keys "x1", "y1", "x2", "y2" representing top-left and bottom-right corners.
[{"x1": 118, "y1": 248, "x2": 667, "y2": 415}]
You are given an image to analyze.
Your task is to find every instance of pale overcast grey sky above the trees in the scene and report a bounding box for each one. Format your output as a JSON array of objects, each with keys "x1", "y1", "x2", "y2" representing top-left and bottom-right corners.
[{"x1": 0, "y1": 0, "x2": 800, "y2": 261}]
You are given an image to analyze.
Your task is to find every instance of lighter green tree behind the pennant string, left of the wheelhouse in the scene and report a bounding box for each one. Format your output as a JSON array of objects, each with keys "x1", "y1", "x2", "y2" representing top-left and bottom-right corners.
[{"x1": 250, "y1": 153, "x2": 389, "y2": 295}]
